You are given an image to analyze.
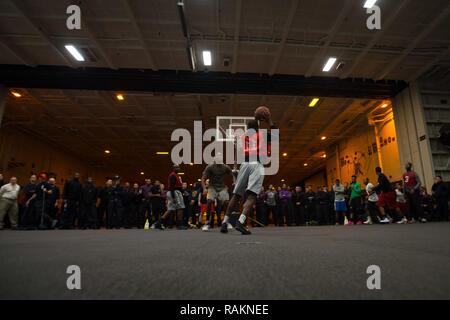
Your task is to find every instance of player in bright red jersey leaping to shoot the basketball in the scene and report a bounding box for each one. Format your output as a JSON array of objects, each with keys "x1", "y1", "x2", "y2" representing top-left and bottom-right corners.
[{"x1": 220, "y1": 112, "x2": 277, "y2": 235}]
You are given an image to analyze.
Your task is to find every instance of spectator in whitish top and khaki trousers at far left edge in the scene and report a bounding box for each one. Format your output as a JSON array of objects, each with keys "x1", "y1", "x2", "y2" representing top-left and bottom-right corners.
[{"x1": 0, "y1": 177, "x2": 20, "y2": 230}]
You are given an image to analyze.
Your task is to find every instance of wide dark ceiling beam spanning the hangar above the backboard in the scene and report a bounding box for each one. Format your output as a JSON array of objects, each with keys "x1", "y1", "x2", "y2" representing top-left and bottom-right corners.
[{"x1": 0, "y1": 65, "x2": 407, "y2": 99}]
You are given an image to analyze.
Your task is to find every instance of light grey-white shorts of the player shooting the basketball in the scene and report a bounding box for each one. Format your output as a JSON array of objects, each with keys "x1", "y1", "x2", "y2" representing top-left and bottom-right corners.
[{"x1": 233, "y1": 162, "x2": 264, "y2": 196}]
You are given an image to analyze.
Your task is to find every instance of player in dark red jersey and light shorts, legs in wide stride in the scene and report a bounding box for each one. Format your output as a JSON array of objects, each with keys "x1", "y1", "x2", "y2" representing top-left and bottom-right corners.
[{"x1": 155, "y1": 165, "x2": 187, "y2": 230}]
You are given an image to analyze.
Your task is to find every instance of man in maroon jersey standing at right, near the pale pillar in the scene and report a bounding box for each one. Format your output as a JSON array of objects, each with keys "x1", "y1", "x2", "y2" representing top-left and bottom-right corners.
[{"x1": 403, "y1": 162, "x2": 427, "y2": 222}]
